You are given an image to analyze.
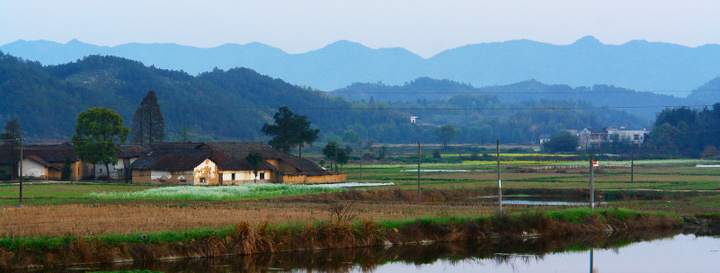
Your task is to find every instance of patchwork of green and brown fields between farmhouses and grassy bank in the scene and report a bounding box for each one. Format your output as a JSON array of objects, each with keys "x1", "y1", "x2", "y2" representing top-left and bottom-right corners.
[{"x1": 0, "y1": 157, "x2": 720, "y2": 237}]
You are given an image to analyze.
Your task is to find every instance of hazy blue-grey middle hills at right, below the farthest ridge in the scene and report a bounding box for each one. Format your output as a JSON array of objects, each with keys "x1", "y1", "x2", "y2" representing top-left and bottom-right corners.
[{"x1": 330, "y1": 77, "x2": 688, "y2": 119}]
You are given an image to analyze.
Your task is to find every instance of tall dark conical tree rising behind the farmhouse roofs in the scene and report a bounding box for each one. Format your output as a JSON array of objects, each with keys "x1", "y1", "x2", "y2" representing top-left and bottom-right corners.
[{"x1": 130, "y1": 91, "x2": 165, "y2": 144}]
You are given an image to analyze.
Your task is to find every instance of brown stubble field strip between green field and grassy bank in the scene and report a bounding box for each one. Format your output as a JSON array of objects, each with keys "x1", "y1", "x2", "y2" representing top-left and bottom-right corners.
[{"x1": 0, "y1": 198, "x2": 506, "y2": 238}]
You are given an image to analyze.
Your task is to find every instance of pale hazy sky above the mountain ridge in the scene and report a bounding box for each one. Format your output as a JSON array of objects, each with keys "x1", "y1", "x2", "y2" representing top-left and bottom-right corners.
[{"x1": 0, "y1": 0, "x2": 720, "y2": 57}]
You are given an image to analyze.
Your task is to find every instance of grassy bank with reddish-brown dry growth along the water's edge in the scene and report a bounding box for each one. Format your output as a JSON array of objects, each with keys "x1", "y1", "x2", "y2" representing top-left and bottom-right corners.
[{"x1": 0, "y1": 208, "x2": 682, "y2": 270}]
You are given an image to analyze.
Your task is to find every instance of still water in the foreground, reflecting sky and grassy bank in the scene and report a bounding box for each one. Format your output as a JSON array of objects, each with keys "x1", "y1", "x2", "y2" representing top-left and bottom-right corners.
[{"x1": 35, "y1": 228, "x2": 720, "y2": 273}]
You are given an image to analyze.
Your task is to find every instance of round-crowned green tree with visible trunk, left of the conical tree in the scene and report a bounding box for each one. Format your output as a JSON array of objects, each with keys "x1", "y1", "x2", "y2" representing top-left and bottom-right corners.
[{"x1": 72, "y1": 107, "x2": 130, "y2": 181}]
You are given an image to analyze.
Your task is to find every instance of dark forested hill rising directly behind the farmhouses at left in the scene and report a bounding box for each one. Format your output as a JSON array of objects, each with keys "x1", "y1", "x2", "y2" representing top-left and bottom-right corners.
[{"x1": 0, "y1": 53, "x2": 405, "y2": 141}]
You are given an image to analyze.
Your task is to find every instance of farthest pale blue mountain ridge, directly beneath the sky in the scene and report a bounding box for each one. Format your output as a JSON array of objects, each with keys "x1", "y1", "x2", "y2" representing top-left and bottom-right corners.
[{"x1": 0, "y1": 36, "x2": 720, "y2": 92}]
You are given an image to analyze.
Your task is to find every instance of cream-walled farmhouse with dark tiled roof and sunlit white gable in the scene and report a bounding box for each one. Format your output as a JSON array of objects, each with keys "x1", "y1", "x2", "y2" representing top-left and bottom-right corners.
[{"x1": 130, "y1": 142, "x2": 347, "y2": 185}]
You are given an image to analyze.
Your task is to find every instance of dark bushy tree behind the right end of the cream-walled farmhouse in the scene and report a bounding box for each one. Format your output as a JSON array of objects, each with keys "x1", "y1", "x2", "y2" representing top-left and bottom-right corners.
[{"x1": 262, "y1": 106, "x2": 320, "y2": 157}]
